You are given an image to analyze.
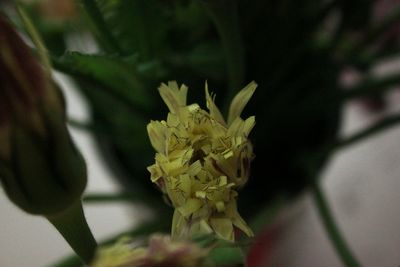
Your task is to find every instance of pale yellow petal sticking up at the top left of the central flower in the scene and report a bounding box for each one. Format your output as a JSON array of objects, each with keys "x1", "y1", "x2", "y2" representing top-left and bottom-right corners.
[{"x1": 158, "y1": 81, "x2": 188, "y2": 114}]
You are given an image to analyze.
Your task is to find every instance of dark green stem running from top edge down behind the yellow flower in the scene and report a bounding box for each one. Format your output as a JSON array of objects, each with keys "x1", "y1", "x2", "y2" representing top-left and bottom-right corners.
[{"x1": 202, "y1": 0, "x2": 245, "y2": 111}]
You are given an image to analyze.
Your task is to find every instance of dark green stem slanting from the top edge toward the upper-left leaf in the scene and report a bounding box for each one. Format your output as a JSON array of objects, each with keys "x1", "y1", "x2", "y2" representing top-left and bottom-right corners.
[{"x1": 82, "y1": 0, "x2": 123, "y2": 55}]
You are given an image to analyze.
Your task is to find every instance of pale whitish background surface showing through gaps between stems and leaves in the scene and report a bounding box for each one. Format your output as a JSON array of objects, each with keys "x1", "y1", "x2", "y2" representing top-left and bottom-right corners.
[{"x1": 0, "y1": 71, "x2": 400, "y2": 267}]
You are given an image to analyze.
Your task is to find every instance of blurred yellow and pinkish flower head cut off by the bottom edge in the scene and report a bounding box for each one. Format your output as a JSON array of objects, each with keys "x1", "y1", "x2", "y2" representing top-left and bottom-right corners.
[{"x1": 91, "y1": 234, "x2": 207, "y2": 267}]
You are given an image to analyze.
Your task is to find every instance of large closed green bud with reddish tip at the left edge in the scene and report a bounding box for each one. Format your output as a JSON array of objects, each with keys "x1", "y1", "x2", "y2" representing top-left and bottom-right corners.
[{"x1": 0, "y1": 15, "x2": 86, "y2": 216}]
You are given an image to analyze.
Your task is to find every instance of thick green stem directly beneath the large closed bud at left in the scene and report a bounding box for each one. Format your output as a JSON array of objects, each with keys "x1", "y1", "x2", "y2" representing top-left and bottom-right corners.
[{"x1": 47, "y1": 201, "x2": 97, "y2": 264}]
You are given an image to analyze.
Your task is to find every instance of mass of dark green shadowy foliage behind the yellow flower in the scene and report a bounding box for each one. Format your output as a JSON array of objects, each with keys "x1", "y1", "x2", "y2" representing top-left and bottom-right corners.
[{"x1": 17, "y1": 0, "x2": 399, "y2": 220}]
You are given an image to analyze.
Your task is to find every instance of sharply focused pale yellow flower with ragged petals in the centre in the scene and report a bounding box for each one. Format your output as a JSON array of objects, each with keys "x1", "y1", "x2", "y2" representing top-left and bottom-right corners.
[{"x1": 147, "y1": 81, "x2": 257, "y2": 241}]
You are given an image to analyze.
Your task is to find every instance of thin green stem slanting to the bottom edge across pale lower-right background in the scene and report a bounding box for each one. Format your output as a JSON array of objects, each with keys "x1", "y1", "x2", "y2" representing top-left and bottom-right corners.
[{"x1": 312, "y1": 181, "x2": 361, "y2": 267}]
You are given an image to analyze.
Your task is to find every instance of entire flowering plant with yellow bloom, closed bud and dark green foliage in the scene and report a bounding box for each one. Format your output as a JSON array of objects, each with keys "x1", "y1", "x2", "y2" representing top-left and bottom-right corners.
[{"x1": 0, "y1": 0, "x2": 400, "y2": 267}]
